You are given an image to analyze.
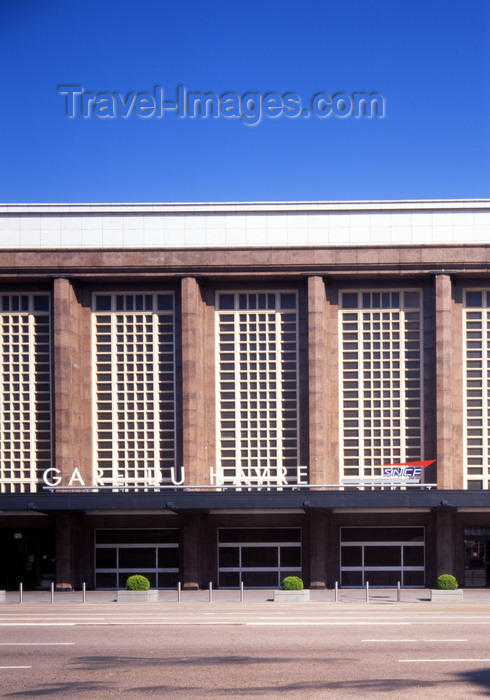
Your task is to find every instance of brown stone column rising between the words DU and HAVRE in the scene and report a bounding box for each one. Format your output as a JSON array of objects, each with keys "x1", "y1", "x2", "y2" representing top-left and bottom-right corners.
[{"x1": 181, "y1": 277, "x2": 215, "y2": 485}]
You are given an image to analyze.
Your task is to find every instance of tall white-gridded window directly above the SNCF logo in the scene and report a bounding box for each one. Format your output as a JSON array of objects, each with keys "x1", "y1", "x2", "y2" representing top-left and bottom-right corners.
[{"x1": 340, "y1": 290, "x2": 423, "y2": 478}]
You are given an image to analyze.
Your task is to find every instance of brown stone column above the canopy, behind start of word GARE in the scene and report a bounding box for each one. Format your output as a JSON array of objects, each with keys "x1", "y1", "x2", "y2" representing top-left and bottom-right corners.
[{"x1": 53, "y1": 278, "x2": 92, "y2": 486}]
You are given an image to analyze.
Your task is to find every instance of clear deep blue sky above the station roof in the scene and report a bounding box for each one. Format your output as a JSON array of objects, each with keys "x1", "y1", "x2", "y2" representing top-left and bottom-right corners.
[{"x1": 0, "y1": 0, "x2": 490, "y2": 202}]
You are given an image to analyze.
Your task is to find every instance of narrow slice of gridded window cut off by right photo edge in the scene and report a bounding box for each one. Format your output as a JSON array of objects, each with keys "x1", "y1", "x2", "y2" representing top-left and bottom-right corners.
[{"x1": 463, "y1": 289, "x2": 490, "y2": 490}]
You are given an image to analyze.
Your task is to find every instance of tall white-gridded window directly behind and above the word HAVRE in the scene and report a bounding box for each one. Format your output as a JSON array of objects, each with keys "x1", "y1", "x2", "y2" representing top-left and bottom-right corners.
[{"x1": 217, "y1": 292, "x2": 298, "y2": 485}]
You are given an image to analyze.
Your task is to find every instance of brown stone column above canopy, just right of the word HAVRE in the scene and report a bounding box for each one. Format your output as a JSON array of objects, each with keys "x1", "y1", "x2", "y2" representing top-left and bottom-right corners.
[{"x1": 308, "y1": 276, "x2": 339, "y2": 484}]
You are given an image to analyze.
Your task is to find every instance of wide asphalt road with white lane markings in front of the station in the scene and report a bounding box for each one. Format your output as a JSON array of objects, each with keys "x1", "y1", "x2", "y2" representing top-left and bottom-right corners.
[{"x1": 0, "y1": 603, "x2": 490, "y2": 700}]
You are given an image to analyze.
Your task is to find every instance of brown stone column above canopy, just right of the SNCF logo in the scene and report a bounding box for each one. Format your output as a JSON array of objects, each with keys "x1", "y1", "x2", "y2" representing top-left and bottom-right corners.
[{"x1": 435, "y1": 274, "x2": 463, "y2": 489}]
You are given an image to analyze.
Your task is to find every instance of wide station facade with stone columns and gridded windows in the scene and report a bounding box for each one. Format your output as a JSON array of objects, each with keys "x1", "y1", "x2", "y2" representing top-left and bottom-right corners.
[{"x1": 0, "y1": 200, "x2": 490, "y2": 589}]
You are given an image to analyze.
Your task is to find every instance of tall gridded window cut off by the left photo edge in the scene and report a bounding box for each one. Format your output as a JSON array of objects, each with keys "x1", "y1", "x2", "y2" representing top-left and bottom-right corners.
[{"x1": 0, "y1": 294, "x2": 52, "y2": 493}]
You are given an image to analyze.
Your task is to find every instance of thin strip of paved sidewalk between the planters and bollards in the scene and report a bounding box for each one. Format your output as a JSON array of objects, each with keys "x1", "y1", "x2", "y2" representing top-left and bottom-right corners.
[{"x1": 5, "y1": 588, "x2": 490, "y2": 605}]
